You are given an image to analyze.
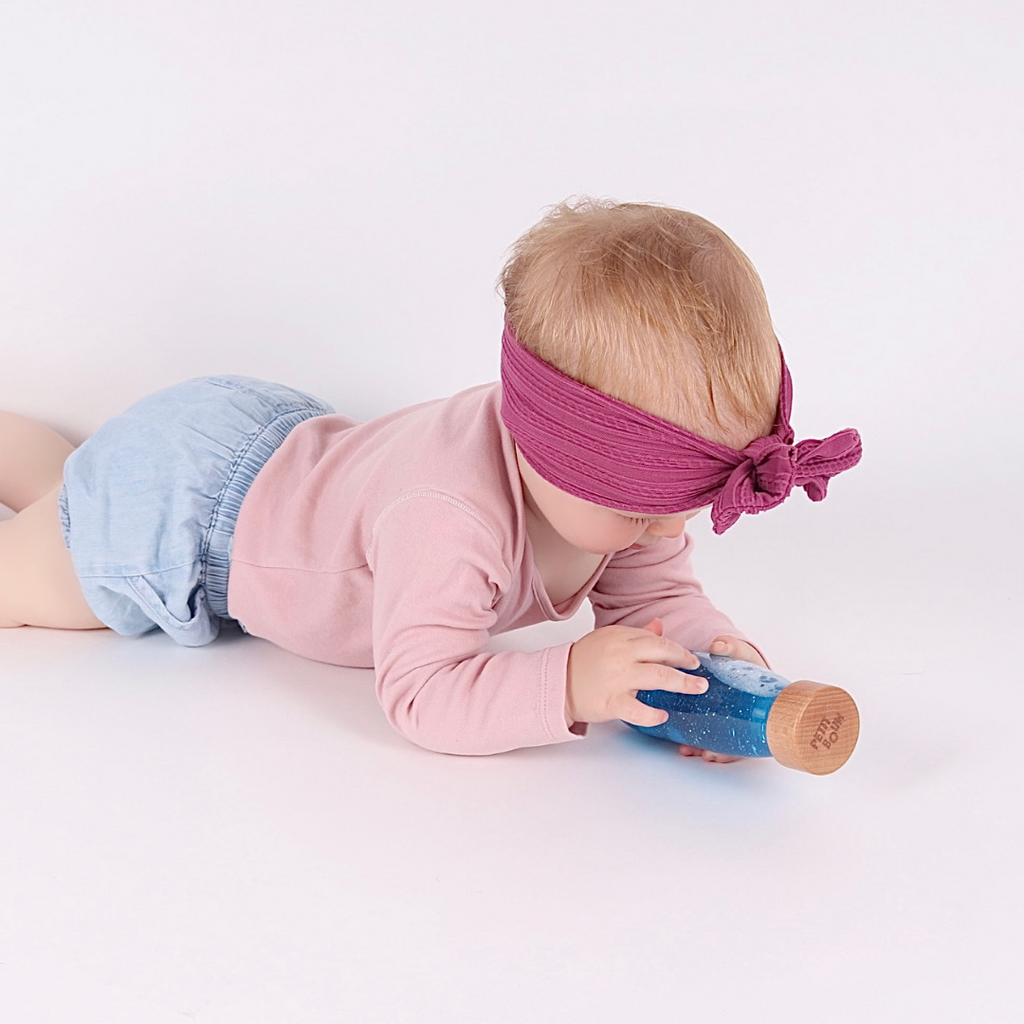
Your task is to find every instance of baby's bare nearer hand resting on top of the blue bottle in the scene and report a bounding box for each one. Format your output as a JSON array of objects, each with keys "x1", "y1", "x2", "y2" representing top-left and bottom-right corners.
[{"x1": 565, "y1": 618, "x2": 708, "y2": 727}]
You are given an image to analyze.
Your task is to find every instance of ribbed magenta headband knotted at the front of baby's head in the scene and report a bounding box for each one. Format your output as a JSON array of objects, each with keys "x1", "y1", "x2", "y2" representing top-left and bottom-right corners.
[{"x1": 502, "y1": 321, "x2": 861, "y2": 534}]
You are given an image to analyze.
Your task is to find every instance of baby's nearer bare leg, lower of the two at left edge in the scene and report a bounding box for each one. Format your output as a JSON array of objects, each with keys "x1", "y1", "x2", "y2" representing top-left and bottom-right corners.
[{"x1": 0, "y1": 483, "x2": 103, "y2": 630}]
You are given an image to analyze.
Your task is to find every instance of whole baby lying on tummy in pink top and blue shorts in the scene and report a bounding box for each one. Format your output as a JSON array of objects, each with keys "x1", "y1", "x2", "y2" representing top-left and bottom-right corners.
[{"x1": 0, "y1": 200, "x2": 860, "y2": 760}]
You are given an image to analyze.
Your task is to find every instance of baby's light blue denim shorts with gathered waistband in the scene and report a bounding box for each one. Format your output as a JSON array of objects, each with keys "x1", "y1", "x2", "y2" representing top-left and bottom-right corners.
[{"x1": 60, "y1": 377, "x2": 333, "y2": 647}]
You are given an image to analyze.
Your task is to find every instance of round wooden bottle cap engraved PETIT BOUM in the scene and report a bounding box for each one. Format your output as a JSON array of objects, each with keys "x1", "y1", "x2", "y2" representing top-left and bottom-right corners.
[{"x1": 767, "y1": 679, "x2": 860, "y2": 775}]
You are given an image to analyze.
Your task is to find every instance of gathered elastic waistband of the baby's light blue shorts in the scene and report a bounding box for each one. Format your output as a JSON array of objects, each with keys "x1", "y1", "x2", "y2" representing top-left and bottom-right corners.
[{"x1": 202, "y1": 406, "x2": 331, "y2": 618}]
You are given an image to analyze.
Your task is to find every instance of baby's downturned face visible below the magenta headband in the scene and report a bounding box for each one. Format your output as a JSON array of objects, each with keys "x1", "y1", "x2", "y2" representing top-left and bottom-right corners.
[{"x1": 517, "y1": 453, "x2": 700, "y2": 555}]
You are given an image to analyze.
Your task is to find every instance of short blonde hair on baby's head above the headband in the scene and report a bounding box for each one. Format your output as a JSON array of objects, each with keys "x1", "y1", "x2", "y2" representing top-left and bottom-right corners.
[{"x1": 499, "y1": 198, "x2": 781, "y2": 449}]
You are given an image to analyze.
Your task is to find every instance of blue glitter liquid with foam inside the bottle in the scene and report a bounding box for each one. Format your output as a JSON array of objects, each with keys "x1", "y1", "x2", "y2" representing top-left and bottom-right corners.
[{"x1": 632, "y1": 651, "x2": 790, "y2": 758}]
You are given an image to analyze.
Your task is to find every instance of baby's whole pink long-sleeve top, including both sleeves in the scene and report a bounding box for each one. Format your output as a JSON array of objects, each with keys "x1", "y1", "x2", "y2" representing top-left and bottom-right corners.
[{"x1": 228, "y1": 384, "x2": 737, "y2": 754}]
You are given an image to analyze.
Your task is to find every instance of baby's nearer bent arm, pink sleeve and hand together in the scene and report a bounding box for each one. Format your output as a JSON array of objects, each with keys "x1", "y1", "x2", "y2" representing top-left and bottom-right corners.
[{"x1": 369, "y1": 493, "x2": 761, "y2": 754}]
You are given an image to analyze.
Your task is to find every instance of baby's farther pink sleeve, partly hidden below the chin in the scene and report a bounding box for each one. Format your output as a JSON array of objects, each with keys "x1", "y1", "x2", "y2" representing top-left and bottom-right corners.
[{"x1": 590, "y1": 532, "x2": 746, "y2": 650}]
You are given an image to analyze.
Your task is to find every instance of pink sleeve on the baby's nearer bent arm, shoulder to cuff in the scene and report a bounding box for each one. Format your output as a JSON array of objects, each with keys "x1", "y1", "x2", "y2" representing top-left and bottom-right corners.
[{"x1": 369, "y1": 492, "x2": 579, "y2": 754}]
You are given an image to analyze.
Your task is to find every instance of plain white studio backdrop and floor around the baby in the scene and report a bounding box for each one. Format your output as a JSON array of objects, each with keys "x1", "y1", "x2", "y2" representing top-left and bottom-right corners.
[{"x1": 0, "y1": 0, "x2": 1024, "y2": 1024}]
